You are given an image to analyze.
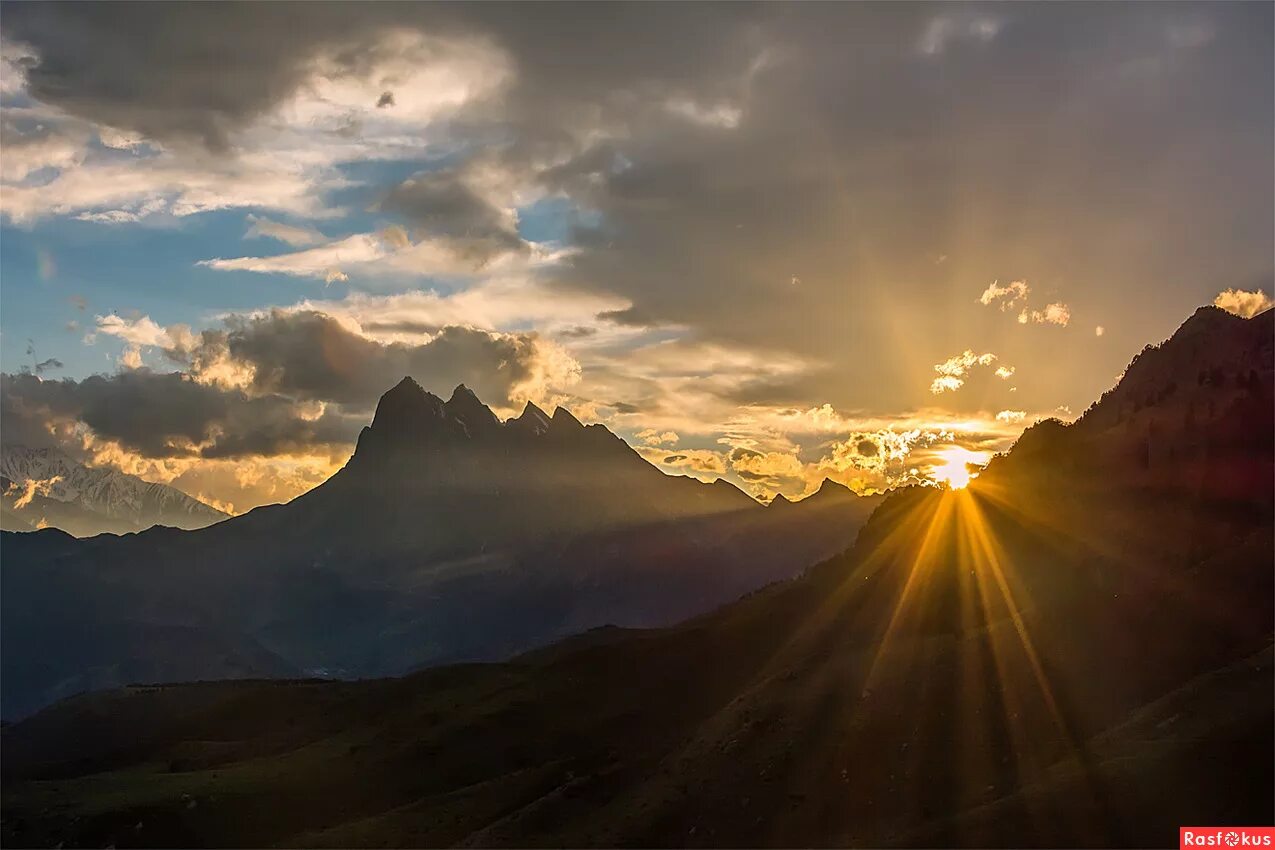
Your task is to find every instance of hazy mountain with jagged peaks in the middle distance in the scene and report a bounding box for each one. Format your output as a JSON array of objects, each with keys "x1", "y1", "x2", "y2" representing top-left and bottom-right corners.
[{"x1": 0, "y1": 378, "x2": 878, "y2": 719}]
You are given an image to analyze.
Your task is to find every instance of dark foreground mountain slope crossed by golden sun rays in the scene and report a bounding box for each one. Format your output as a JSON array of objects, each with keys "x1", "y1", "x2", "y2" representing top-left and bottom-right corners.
[{"x1": 3, "y1": 304, "x2": 1275, "y2": 846}]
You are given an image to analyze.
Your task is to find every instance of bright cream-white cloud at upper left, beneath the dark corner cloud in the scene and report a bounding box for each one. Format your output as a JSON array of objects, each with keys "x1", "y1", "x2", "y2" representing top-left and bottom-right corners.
[{"x1": 0, "y1": 18, "x2": 511, "y2": 223}]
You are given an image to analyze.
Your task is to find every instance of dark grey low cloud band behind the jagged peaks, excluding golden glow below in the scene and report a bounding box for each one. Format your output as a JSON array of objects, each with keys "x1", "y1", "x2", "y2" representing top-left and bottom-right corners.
[{"x1": 0, "y1": 311, "x2": 558, "y2": 457}]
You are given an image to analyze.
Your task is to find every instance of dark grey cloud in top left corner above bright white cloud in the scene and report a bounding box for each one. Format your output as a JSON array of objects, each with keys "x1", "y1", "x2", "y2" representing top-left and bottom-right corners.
[{"x1": 4, "y1": 3, "x2": 333, "y2": 149}]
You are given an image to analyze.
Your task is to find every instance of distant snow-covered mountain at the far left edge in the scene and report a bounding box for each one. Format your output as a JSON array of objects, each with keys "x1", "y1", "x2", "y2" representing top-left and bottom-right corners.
[{"x1": 0, "y1": 445, "x2": 227, "y2": 537}]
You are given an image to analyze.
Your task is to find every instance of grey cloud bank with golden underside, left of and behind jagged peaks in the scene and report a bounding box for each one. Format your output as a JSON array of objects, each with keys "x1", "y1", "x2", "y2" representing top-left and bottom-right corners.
[{"x1": 0, "y1": 302, "x2": 580, "y2": 510}]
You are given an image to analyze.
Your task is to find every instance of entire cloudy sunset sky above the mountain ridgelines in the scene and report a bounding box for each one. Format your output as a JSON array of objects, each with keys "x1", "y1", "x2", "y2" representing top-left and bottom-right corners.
[{"x1": 0, "y1": 3, "x2": 1275, "y2": 512}]
